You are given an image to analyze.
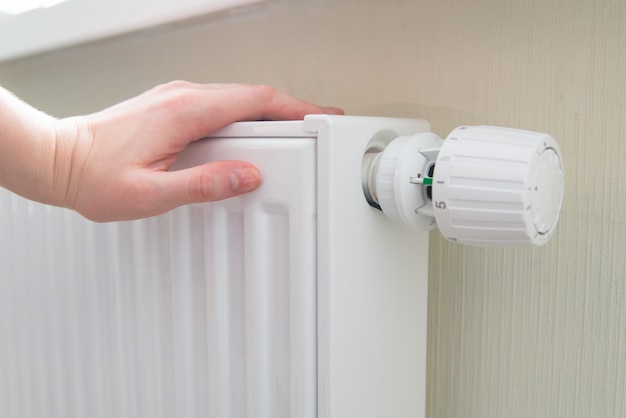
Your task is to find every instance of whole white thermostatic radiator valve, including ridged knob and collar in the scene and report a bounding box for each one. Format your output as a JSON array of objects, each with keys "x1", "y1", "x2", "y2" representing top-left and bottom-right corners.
[{"x1": 363, "y1": 126, "x2": 563, "y2": 246}]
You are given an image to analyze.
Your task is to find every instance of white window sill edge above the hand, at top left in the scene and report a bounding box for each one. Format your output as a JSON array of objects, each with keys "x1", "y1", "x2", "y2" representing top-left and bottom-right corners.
[{"x1": 0, "y1": 0, "x2": 265, "y2": 61}]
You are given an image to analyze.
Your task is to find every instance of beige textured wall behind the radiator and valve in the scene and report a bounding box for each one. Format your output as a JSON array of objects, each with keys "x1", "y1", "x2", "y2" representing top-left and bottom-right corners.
[{"x1": 0, "y1": 0, "x2": 626, "y2": 418}]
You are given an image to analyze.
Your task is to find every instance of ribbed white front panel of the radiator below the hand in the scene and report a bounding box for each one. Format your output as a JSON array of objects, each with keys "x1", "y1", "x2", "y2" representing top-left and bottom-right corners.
[{"x1": 0, "y1": 138, "x2": 317, "y2": 418}]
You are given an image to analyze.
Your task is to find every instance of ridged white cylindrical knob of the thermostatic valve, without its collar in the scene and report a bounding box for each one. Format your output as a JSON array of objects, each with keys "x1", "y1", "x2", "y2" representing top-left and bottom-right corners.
[{"x1": 433, "y1": 126, "x2": 563, "y2": 246}]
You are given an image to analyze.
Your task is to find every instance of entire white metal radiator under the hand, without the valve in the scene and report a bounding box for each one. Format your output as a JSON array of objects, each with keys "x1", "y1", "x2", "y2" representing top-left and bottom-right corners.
[{"x1": 0, "y1": 116, "x2": 429, "y2": 418}]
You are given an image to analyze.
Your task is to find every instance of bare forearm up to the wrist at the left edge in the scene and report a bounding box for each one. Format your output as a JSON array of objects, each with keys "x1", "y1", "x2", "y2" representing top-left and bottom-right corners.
[{"x1": 0, "y1": 88, "x2": 62, "y2": 205}]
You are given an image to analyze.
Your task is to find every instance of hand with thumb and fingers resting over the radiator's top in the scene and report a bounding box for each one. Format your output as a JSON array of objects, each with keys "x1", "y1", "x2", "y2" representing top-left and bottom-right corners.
[{"x1": 47, "y1": 82, "x2": 343, "y2": 221}]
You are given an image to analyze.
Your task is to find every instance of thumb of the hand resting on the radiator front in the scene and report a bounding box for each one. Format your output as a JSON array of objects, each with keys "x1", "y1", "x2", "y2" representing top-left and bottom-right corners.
[{"x1": 165, "y1": 161, "x2": 261, "y2": 207}]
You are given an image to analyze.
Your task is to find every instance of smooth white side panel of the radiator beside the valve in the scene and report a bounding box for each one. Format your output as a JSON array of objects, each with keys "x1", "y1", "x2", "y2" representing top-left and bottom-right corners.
[{"x1": 305, "y1": 115, "x2": 429, "y2": 418}]
